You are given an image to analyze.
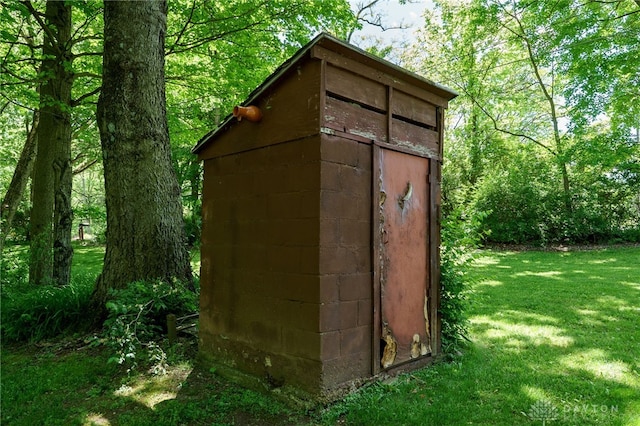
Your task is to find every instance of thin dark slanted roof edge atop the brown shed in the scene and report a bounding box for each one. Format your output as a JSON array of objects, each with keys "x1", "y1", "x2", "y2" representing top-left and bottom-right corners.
[{"x1": 192, "y1": 33, "x2": 458, "y2": 154}]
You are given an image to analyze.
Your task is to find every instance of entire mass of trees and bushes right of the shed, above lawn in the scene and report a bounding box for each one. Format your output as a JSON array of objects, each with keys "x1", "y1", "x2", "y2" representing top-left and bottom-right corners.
[{"x1": 405, "y1": 0, "x2": 640, "y2": 245}]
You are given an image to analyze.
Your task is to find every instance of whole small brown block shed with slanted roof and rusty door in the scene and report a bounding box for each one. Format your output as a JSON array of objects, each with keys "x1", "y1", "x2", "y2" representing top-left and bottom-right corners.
[{"x1": 193, "y1": 34, "x2": 456, "y2": 400}]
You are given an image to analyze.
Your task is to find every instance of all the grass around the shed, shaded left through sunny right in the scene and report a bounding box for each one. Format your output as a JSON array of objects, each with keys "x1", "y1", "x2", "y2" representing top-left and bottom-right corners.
[{"x1": 1, "y1": 248, "x2": 640, "y2": 425}]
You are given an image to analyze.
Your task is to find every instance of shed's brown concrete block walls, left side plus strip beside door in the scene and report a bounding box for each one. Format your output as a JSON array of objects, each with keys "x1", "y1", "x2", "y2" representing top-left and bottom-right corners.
[{"x1": 200, "y1": 131, "x2": 373, "y2": 395}]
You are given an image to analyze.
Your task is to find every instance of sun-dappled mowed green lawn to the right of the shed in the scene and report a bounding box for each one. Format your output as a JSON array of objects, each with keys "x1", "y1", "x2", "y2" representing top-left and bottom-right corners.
[{"x1": 334, "y1": 247, "x2": 640, "y2": 425}]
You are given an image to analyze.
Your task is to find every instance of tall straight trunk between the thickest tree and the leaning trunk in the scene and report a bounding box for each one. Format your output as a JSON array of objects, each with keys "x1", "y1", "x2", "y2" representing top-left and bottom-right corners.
[{"x1": 29, "y1": 0, "x2": 73, "y2": 284}]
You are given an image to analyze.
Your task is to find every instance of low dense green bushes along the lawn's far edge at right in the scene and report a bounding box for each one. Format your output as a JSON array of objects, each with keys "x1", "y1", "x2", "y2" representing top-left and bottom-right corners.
[{"x1": 470, "y1": 139, "x2": 640, "y2": 246}]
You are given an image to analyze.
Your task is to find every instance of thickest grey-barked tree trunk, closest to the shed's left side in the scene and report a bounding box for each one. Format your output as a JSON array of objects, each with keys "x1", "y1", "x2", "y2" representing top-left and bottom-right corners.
[{"x1": 94, "y1": 0, "x2": 192, "y2": 305}]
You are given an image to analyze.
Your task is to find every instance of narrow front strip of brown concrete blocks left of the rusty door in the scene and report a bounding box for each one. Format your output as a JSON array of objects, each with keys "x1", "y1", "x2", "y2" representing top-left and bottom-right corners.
[{"x1": 319, "y1": 135, "x2": 373, "y2": 388}]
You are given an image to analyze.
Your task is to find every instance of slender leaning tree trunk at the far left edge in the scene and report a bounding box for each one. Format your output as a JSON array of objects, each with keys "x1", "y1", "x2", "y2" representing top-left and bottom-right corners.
[{"x1": 0, "y1": 111, "x2": 39, "y2": 253}]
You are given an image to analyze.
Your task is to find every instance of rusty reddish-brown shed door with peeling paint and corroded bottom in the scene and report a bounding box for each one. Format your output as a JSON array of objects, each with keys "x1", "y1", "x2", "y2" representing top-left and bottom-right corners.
[{"x1": 373, "y1": 147, "x2": 431, "y2": 371}]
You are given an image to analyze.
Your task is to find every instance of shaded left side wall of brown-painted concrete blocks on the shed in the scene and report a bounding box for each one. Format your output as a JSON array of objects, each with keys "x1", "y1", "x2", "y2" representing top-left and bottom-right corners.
[{"x1": 200, "y1": 136, "x2": 323, "y2": 394}]
